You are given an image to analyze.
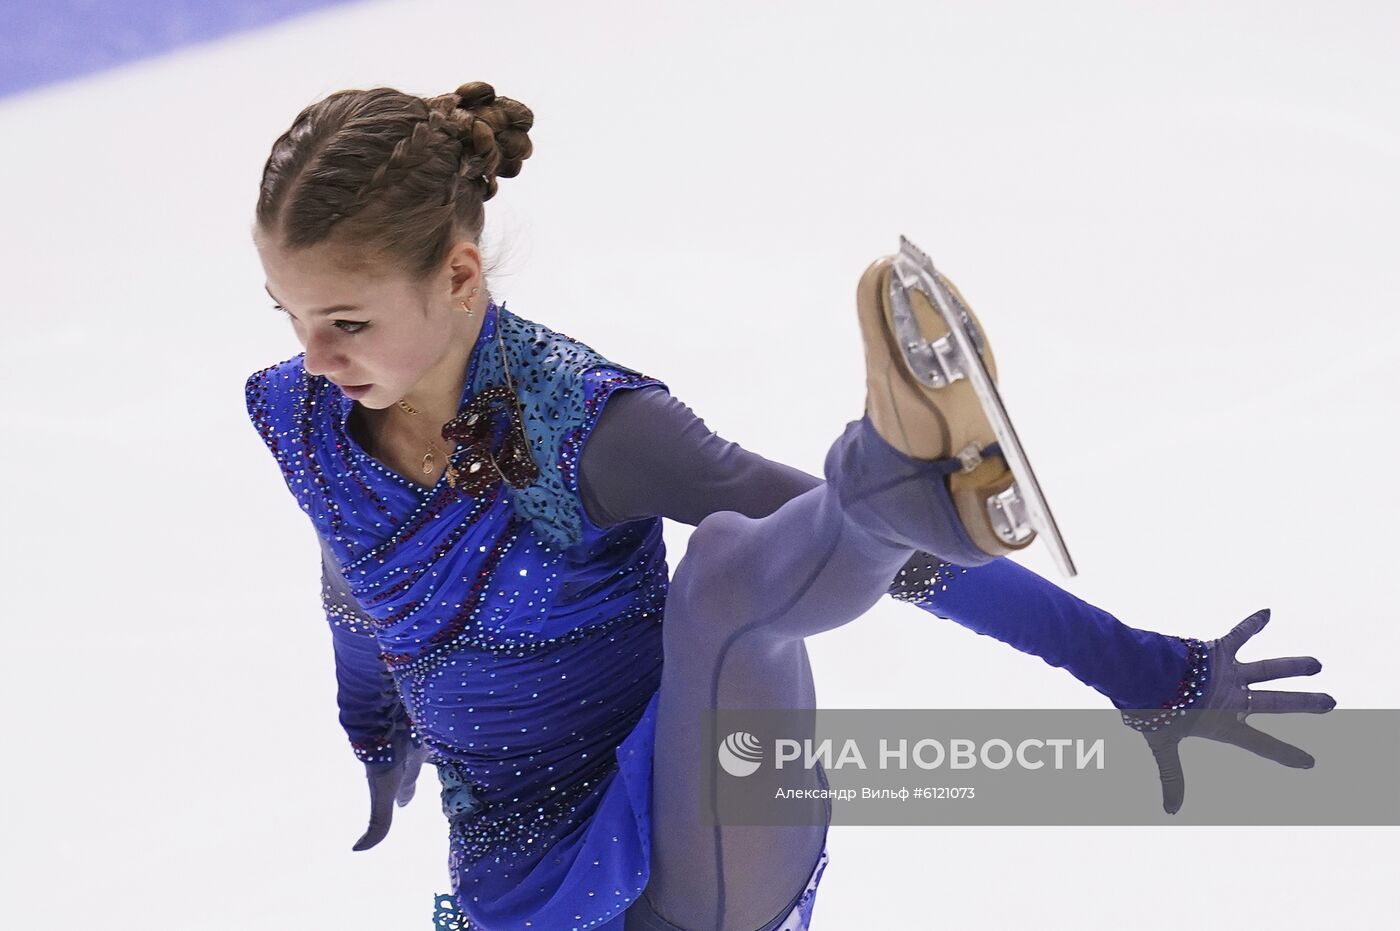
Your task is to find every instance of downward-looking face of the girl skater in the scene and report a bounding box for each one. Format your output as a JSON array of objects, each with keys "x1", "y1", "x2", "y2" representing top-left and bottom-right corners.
[{"x1": 253, "y1": 234, "x2": 484, "y2": 409}]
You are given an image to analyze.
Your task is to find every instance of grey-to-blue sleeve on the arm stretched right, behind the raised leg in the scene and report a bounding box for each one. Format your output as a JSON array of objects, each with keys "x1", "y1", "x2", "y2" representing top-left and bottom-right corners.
[{"x1": 578, "y1": 388, "x2": 1189, "y2": 708}]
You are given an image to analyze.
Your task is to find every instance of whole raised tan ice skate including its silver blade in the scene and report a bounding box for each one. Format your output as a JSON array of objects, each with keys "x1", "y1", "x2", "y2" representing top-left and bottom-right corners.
[{"x1": 855, "y1": 237, "x2": 1077, "y2": 577}]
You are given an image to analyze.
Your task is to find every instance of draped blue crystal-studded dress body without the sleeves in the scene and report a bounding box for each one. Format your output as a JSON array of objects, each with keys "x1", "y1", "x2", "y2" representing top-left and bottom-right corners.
[{"x1": 246, "y1": 302, "x2": 680, "y2": 931}]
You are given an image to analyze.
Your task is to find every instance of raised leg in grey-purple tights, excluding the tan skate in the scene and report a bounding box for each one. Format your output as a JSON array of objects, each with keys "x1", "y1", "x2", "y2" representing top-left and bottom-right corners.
[{"x1": 630, "y1": 417, "x2": 986, "y2": 931}]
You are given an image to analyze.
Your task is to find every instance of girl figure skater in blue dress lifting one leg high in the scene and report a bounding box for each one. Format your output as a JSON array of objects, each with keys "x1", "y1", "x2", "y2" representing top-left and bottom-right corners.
[{"x1": 246, "y1": 83, "x2": 1330, "y2": 931}]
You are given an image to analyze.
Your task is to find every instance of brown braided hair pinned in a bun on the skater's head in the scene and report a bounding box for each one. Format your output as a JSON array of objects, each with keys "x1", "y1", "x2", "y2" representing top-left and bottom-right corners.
[{"x1": 255, "y1": 81, "x2": 535, "y2": 280}]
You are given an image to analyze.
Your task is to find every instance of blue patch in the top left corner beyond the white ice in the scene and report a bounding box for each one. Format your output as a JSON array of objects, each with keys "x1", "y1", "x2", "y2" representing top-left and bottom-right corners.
[{"x1": 0, "y1": 0, "x2": 369, "y2": 97}]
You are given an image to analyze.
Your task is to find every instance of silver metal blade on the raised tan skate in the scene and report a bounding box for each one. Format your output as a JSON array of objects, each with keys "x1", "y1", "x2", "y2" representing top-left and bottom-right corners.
[{"x1": 888, "y1": 237, "x2": 1078, "y2": 578}]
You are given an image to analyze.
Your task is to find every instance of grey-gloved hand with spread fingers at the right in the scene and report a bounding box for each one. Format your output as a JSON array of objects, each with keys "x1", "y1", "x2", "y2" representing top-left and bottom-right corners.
[{"x1": 1125, "y1": 608, "x2": 1337, "y2": 815}]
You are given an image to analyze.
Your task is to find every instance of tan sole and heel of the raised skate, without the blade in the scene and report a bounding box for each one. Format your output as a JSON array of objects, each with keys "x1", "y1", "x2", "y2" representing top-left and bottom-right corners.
[{"x1": 855, "y1": 256, "x2": 1036, "y2": 556}]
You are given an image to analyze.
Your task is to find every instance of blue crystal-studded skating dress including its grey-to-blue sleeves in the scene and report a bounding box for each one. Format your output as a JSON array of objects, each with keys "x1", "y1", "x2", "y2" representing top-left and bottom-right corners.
[{"x1": 246, "y1": 302, "x2": 1189, "y2": 931}]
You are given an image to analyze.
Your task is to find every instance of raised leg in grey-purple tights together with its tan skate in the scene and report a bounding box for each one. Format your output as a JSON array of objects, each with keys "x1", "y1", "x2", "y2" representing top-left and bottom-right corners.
[{"x1": 643, "y1": 248, "x2": 1072, "y2": 931}]
